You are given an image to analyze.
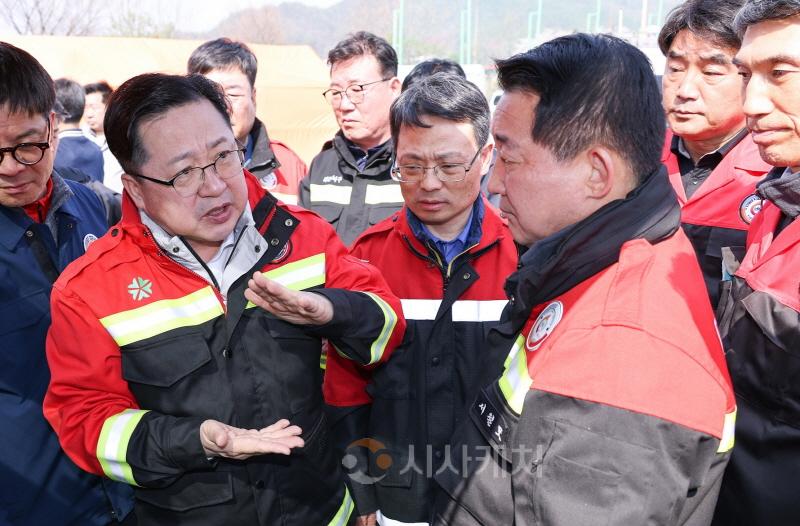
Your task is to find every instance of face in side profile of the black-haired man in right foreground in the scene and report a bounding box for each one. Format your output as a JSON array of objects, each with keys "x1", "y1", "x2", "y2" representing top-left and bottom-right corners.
[{"x1": 489, "y1": 91, "x2": 588, "y2": 246}]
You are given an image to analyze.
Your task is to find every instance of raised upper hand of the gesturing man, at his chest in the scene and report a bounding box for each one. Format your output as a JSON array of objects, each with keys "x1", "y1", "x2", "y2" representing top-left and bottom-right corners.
[{"x1": 244, "y1": 272, "x2": 333, "y2": 325}]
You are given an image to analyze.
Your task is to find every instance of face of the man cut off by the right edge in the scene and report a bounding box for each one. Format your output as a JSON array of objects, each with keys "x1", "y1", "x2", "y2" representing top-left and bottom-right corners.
[{"x1": 736, "y1": 16, "x2": 800, "y2": 171}]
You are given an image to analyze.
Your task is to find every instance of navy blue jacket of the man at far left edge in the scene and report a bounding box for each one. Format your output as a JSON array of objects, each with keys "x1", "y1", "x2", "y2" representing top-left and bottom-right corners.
[{"x1": 0, "y1": 175, "x2": 133, "y2": 526}]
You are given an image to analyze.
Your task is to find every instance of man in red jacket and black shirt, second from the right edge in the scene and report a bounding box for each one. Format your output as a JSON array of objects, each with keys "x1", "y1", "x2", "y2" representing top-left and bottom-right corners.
[{"x1": 658, "y1": 0, "x2": 770, "y2": 307}]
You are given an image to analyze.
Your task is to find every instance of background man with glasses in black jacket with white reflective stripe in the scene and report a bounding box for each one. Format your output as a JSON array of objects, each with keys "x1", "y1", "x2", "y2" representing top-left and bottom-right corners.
[{"x1": 298, "y1": 31, "x2": 403, "y2": 245}]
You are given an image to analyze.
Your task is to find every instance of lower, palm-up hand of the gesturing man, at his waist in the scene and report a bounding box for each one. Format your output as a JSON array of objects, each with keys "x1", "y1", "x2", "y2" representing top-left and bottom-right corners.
[{"x1": 200, "y1": 419, "x2": 303, "y2": 460}]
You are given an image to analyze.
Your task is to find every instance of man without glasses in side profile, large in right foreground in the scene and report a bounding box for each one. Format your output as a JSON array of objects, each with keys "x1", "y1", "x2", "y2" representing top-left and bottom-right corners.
[{"x1": 433, "y1": 34, "x2": 735, "y2": 526}]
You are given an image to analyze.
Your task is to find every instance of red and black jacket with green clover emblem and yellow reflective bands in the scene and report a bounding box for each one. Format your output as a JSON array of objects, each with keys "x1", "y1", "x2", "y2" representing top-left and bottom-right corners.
[{"x1": 44, "y1": 174, "x2": 404, "y2": 526}]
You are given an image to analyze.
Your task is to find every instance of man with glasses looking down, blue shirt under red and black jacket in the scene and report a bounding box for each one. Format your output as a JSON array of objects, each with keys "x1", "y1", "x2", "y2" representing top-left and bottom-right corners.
[{"x1": 324, "y1": 73, "x2": 517, "y2": 524}]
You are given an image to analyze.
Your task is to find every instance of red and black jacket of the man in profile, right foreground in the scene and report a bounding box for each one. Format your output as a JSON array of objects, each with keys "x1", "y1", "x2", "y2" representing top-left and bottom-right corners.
[{"x1": 433, "y1": 171, "x2": 735, "y2": 526}]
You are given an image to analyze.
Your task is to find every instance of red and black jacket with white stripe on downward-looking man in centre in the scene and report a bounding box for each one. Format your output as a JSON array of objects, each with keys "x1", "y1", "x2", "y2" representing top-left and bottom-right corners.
[{"x1": 325, "y1": 201, "x2": 518, "y2": 522}]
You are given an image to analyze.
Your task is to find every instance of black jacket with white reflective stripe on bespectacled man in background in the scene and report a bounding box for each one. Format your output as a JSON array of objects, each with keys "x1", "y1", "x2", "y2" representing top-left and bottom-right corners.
[{"x1": 298, "y1": 131, "x2": 403, "y2": 245}]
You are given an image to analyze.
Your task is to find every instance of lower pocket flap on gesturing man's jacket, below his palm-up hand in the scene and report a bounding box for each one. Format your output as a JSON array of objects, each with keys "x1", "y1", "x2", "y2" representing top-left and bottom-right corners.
[{"x1": 135, "y1": 471, "x2": 233, "y2": 512}]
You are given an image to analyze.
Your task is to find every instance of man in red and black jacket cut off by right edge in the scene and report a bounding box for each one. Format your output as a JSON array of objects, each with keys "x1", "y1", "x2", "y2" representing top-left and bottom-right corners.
[{"x1": 714, "y1": 0, "x2": 800, "y2": 526}]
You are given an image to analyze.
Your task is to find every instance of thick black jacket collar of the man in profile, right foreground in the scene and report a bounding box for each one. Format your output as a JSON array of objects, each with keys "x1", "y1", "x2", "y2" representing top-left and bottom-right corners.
[{"x1": 505, "y1": 167, "x2": 680, "y2": 330}]
